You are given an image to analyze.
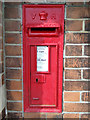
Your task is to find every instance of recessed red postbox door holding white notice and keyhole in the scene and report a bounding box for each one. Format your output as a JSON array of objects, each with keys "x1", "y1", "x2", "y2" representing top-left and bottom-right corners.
[{"x1": 30, "y1": 45, "x2": 57, "y2": 107}]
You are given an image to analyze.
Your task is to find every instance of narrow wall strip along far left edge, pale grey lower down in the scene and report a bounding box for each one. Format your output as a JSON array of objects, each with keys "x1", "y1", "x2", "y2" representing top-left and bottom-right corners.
[{"x1": 0, "y1": 2, "x2": 6, "y2": 120}]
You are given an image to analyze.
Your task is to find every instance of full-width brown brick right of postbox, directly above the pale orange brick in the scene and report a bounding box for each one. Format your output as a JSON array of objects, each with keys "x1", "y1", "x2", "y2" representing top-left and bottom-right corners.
[{"x1": 64, "y1": 81, "x2": 90, "y2": 91}]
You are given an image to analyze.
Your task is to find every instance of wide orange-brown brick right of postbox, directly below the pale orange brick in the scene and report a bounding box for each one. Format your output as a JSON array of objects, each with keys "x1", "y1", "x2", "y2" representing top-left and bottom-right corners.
[{"x1": 64, "y1": 103, "x2": 90, "y2": 112}]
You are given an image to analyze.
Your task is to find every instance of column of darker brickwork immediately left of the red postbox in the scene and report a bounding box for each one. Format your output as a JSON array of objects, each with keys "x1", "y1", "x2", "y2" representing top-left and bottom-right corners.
[{"x1": 5, "y1": 3, "x2": 23, "y2": 118}]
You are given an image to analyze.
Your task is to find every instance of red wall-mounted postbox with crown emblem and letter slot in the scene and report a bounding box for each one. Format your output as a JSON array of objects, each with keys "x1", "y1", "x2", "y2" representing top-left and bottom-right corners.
[{"x1": 23, "y1": 5, "x2": 64, "y2": 112}]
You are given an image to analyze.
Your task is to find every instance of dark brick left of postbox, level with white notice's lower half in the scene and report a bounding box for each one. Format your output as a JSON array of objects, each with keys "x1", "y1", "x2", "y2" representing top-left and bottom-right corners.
[{"x1": 6, "y1": 58, "x2": 22, "y2": 67}]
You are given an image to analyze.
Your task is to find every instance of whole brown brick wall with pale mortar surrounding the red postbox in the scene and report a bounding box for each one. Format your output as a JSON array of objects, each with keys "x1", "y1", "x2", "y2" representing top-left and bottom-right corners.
[{"x1": 4, "y1": 0, "x2": 90, "y2": 119}]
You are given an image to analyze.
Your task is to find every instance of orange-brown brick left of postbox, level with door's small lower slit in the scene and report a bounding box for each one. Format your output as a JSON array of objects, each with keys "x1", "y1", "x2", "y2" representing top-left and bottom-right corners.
[{"x1": 7, "y1": 91, "x2": 22, "y2": 101}]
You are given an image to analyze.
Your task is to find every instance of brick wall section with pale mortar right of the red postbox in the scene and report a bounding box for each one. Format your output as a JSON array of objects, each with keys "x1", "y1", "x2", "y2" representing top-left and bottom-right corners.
[{"x1": 63, "y1": 3, "x2": 90, "y2": 118}]
